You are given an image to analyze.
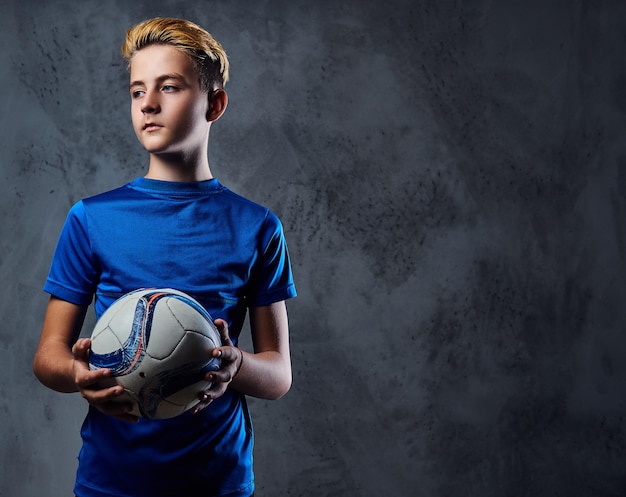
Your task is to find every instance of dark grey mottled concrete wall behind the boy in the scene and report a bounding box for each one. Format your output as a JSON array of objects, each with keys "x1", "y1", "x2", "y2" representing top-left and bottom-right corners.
[{"x1": 0, "y1": 0, "x2": 626, "y2": 497}]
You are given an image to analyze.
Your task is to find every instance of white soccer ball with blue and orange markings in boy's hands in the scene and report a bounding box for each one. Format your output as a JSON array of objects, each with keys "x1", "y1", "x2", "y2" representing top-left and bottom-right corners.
[{"x1": 89, "y1": 288, "x2": 221, "y2": 419}]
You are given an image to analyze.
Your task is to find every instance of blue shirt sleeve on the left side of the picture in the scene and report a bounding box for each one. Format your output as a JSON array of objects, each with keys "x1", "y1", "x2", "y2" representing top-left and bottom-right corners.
[{"x1": 44, "y1": 201, "x2": 98, "y2": 305}]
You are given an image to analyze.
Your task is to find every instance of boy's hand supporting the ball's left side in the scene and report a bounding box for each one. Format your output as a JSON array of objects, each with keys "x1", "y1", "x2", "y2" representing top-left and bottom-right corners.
[{"x1": 72, "y1": 338, "x2": 138, "y2": 422}]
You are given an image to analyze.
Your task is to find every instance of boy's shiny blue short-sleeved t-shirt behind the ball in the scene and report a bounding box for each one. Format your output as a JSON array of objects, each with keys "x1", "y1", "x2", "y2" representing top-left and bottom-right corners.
[{"x1": 44, "y1": 178, "x2": 296, "y2": 497}]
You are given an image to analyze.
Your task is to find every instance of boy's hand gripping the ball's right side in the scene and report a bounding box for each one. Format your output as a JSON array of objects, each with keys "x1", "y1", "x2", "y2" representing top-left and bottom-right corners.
[{"x1": 193, "y1": 319, "x2": 243, "y2": 414}]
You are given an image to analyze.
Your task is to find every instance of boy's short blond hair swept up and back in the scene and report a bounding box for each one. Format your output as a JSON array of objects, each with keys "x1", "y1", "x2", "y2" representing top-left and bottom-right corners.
[{"x1": 121, "y1": 17, "x2": 229, "y2": 92}]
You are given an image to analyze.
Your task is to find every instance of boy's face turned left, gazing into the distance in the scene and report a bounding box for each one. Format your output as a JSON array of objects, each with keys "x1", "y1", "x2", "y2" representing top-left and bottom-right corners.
[{"x1": 130, "y1": 45, "x2": 210, "y2": 156}]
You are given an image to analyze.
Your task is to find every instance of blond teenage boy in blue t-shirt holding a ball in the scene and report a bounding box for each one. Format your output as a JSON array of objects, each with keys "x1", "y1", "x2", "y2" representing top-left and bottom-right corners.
[{"x1": 33, "y1": 18, "x2": 296, "y2": 497}]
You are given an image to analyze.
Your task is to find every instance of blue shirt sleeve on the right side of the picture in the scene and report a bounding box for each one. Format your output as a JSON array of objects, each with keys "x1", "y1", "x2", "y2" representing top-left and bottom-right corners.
[{"x1": 248, "y1": 211, "x2": 296, "y2": 307}]
